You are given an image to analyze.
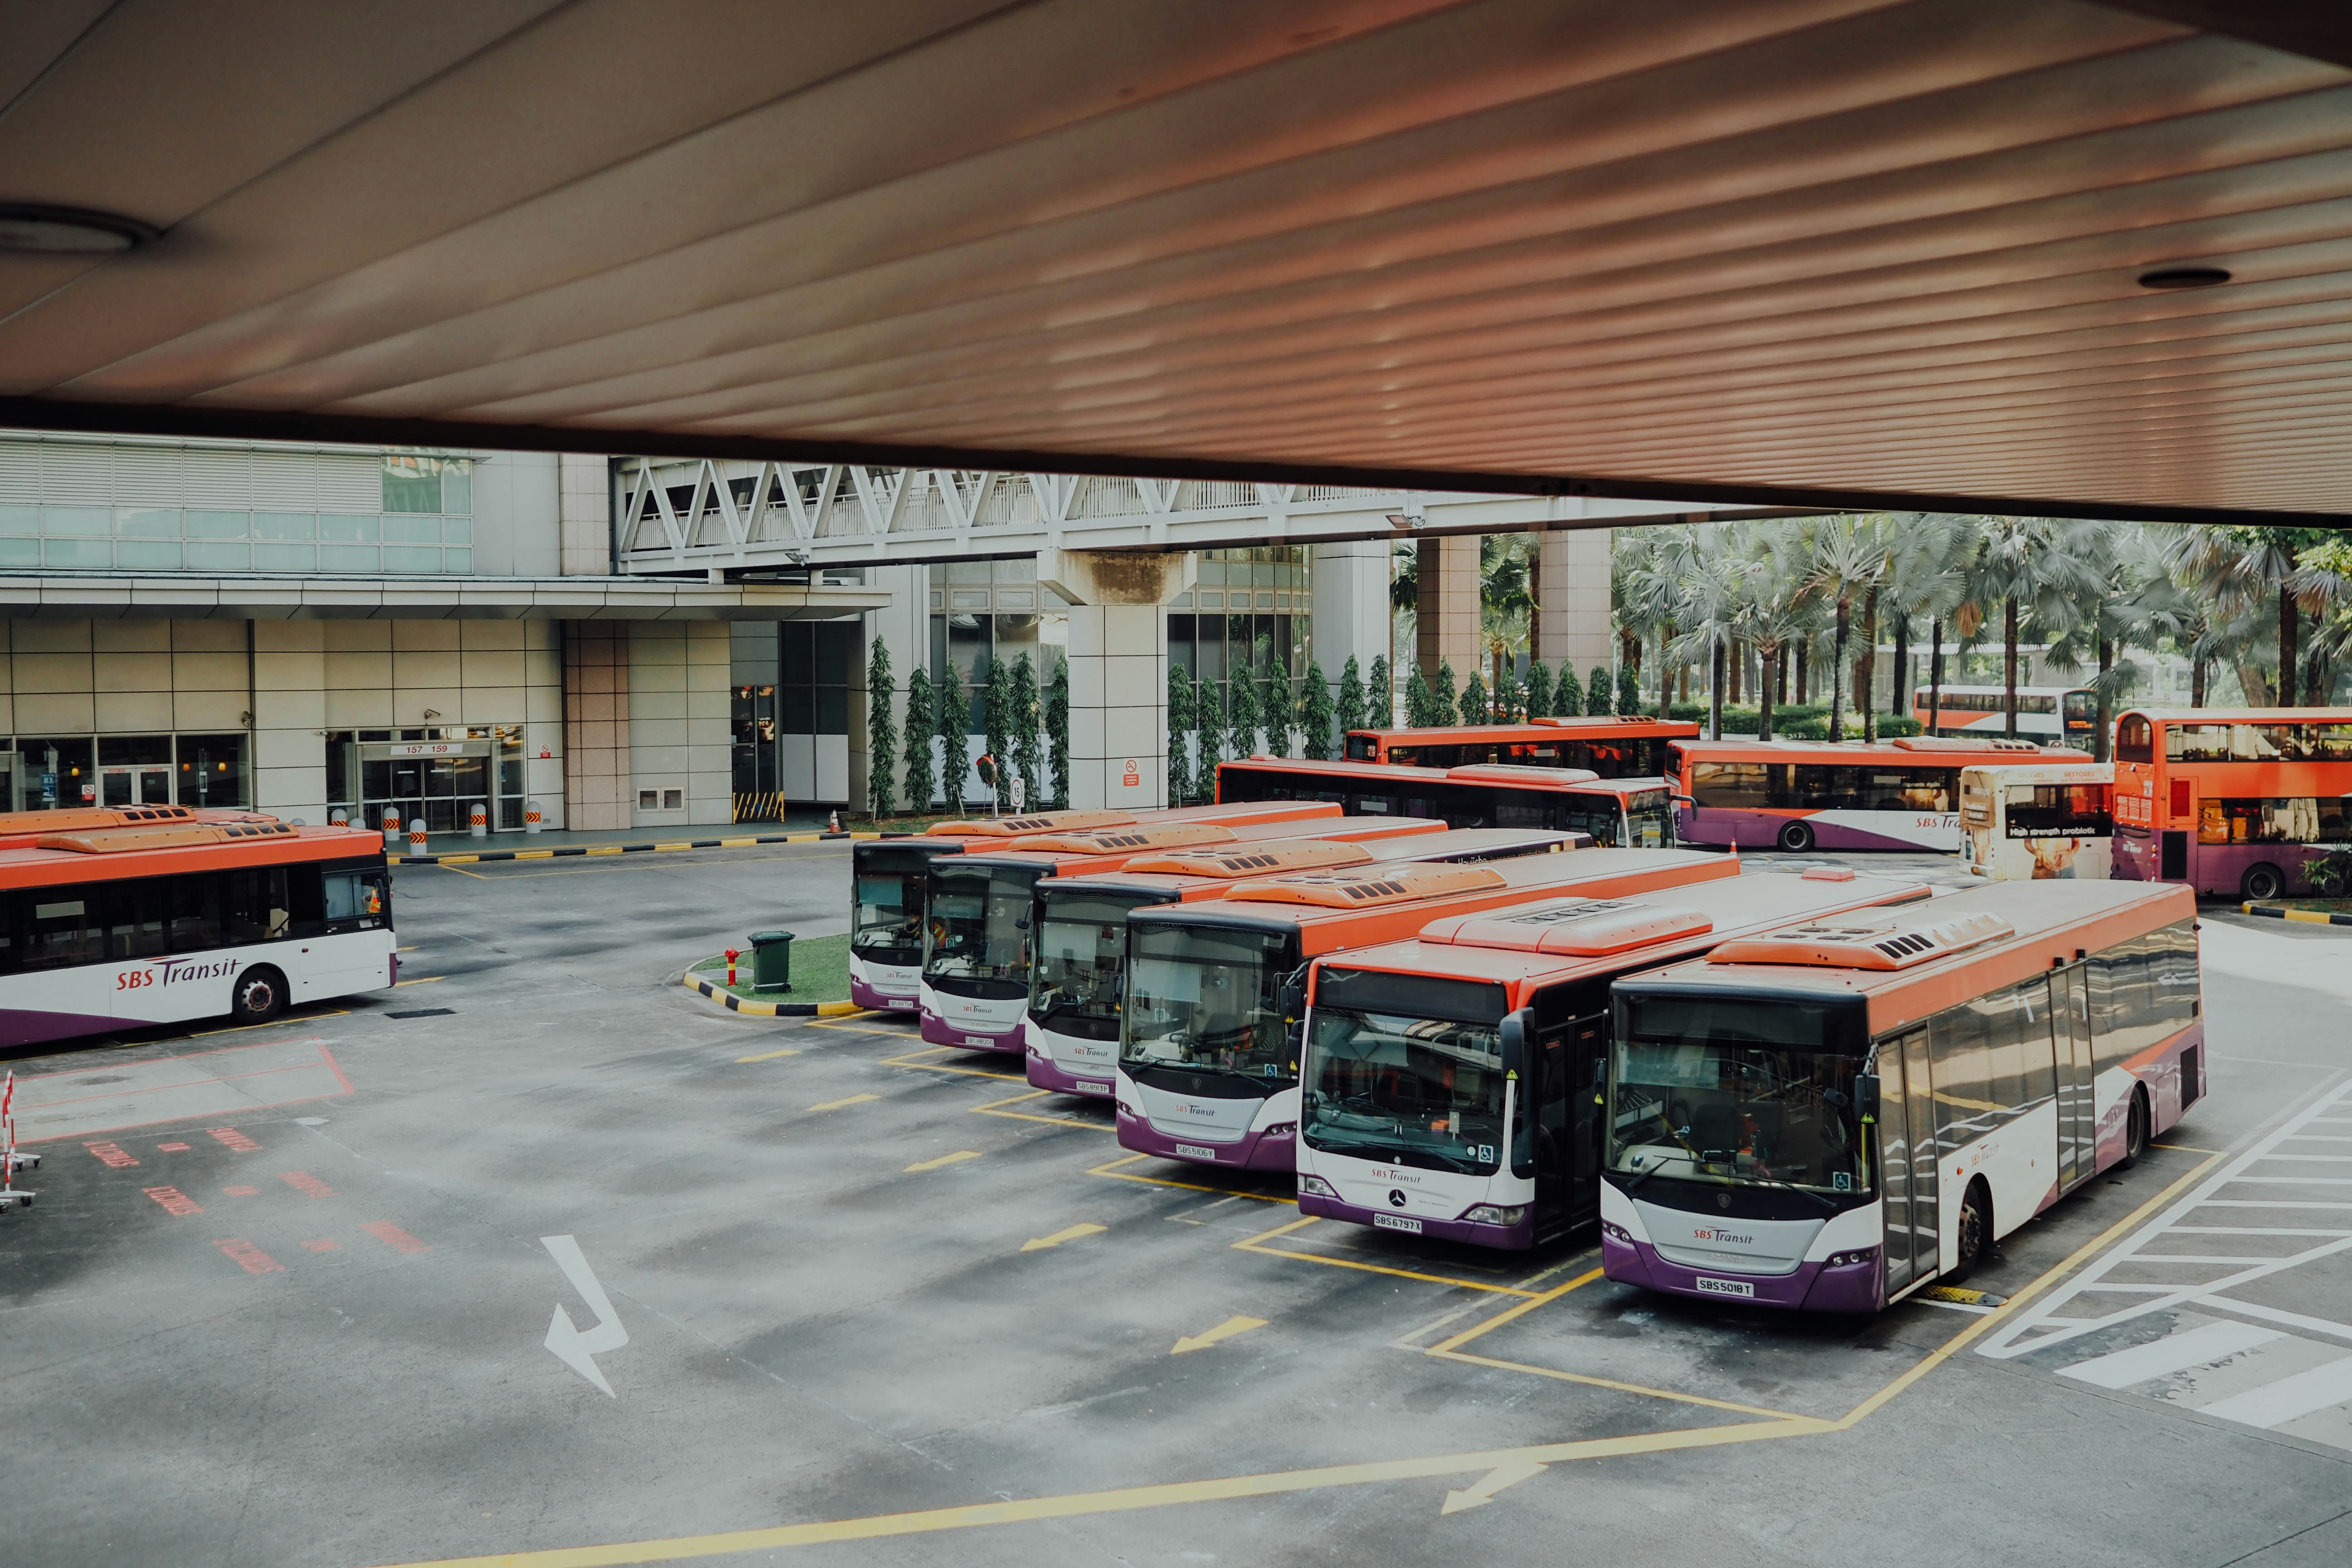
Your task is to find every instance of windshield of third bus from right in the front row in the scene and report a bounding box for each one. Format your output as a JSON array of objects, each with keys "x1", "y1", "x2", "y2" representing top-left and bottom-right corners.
[{"x1": 1120, "y1": 926, "x2": 1298, "y2": 1084}]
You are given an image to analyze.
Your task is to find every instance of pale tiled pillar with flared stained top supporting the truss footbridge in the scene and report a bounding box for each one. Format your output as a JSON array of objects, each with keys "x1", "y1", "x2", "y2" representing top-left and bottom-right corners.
[{"x1": 1037, "y1": 550, "x2": 1197, "y2": 811}]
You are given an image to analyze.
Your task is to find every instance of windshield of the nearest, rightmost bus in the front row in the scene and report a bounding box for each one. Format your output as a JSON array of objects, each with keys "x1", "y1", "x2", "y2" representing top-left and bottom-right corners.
[{"x1": 1609, "y1": 997, "x2": 1870, "y2": 1194}]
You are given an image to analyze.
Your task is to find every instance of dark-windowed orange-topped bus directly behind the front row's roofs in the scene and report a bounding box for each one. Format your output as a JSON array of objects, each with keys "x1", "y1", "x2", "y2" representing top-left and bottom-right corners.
[{"x1": 1216, "y1": 757, "x2": 1675, "y2": 848}]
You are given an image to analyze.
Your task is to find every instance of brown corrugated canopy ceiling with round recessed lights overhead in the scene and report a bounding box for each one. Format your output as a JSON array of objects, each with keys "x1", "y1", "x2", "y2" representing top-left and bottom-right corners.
[{"x1": 0, "y1": 0, "x2": 2352, "y2": 526}]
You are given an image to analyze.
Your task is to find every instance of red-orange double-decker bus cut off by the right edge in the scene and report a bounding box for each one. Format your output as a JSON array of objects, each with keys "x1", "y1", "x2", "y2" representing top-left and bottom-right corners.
[{"x1": 2114, "y1": 708, "x2": 2352, "y2": 898}]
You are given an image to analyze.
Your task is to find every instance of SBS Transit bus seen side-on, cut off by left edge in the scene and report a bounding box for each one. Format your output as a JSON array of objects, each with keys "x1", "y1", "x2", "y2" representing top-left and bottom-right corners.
[{"x1": 0, "y1": 820, "x2": 395, "y2": 1046}]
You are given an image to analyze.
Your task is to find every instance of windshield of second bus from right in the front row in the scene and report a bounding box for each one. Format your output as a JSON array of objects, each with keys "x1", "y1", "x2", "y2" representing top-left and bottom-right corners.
[{"x1": 1298, "y1": 1006, "x2": 1505, "y2": 1176}]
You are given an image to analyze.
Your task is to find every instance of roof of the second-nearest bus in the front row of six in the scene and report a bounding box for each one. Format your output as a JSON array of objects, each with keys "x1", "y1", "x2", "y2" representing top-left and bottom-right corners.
[{"x1": 1315, "y1": 872, "x2": 1929, "y2": 1006}]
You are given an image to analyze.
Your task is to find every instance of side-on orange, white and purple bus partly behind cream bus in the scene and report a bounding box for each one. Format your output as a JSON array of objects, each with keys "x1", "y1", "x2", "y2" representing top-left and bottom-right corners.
[{"x1": 1667, "y1": 736, "x2": 2086, "y2": 853}]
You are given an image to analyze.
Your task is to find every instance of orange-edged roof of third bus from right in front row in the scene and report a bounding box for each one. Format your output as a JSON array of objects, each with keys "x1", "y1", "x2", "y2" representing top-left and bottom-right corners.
[{"x1": 1132, "y1": 848, "x2": 1740, "y2": 957}]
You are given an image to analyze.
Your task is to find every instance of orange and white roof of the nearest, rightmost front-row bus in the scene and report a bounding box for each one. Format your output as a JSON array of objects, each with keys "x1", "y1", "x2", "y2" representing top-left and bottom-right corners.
[{"x1": 1635, "y1": 882, "x2": 2197, "y2": 1037}]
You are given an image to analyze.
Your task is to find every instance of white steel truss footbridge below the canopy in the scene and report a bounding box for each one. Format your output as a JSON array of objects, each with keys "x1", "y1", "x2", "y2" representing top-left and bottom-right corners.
[{"x1": 614, "y1": 458, "x2": 1748, "y2": 573}]
